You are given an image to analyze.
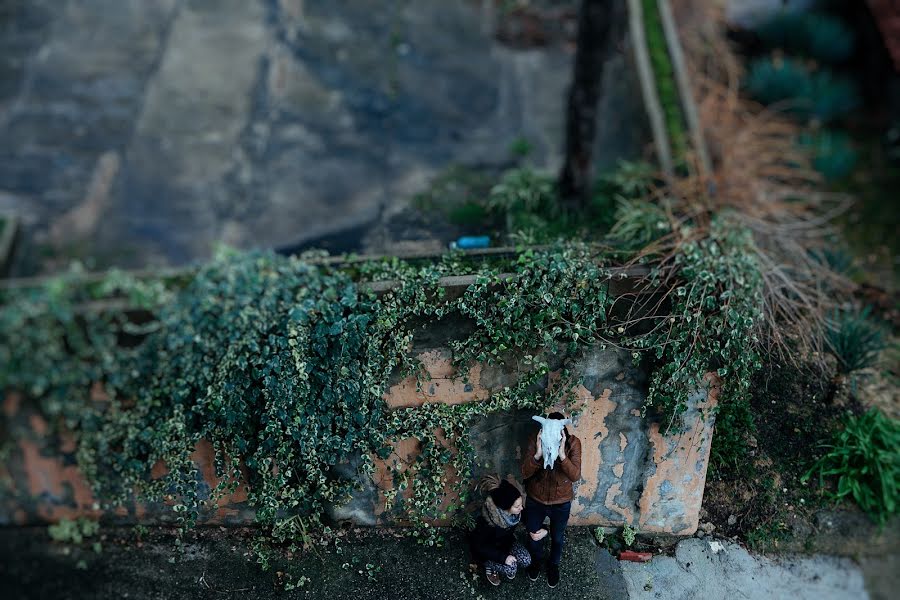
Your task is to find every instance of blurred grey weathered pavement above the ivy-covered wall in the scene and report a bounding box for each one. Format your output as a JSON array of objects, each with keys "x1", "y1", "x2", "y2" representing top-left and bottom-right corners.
[{"x1": 0, "y1": 0, "x2": 648, "y2": 274}]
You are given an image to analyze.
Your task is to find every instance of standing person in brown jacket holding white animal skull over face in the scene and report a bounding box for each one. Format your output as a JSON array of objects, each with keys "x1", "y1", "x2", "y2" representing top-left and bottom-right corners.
[{"x1": 522, "y1": 412, "x2": 581, "y2": 587}]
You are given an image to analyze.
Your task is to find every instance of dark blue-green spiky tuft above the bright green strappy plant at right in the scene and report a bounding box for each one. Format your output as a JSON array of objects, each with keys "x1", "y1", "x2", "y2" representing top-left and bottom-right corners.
[{"x1": 825, "y1": 307, "x2": 887, "y2": 373}]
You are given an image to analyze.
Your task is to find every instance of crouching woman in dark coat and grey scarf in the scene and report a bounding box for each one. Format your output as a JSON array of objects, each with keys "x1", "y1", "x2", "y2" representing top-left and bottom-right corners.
[{"x1": 469, "y1": 477, "x2": 531, "y2": 585}]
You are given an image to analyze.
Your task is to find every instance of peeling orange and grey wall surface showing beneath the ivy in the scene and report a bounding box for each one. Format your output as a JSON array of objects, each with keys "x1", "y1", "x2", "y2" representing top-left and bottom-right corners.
[{"x1": 0, "y1": 328, "x2": 715, "y2": 535}]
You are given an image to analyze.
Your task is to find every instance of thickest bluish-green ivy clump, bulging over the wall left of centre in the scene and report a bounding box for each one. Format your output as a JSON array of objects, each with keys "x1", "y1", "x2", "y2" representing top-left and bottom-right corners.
[{"x1": 82, "y1": 254, "x2": 390, "y2": 531}]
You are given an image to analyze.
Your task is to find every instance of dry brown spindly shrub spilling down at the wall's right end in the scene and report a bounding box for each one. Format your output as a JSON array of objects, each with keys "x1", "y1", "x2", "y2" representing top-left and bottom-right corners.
[{"x1": 624, "y1": 0, "x2": 853, "y2": 362}]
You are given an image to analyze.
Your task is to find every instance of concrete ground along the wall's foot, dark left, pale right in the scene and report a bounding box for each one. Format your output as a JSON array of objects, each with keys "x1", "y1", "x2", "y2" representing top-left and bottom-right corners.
[{"x1": 0, "y1": 528, "x2": 884, "y2": 600}]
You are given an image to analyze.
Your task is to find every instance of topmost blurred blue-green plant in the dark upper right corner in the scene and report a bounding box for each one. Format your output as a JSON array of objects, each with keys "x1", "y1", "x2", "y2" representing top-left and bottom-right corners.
[{"x1": 756, "y1": 11, "x2": 856, "y2": 62}]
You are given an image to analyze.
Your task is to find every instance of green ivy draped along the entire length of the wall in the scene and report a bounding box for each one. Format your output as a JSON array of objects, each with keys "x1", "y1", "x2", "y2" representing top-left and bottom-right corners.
[{"x1": 0, "y1": 216, "x2": 758, "y2": 565}]
